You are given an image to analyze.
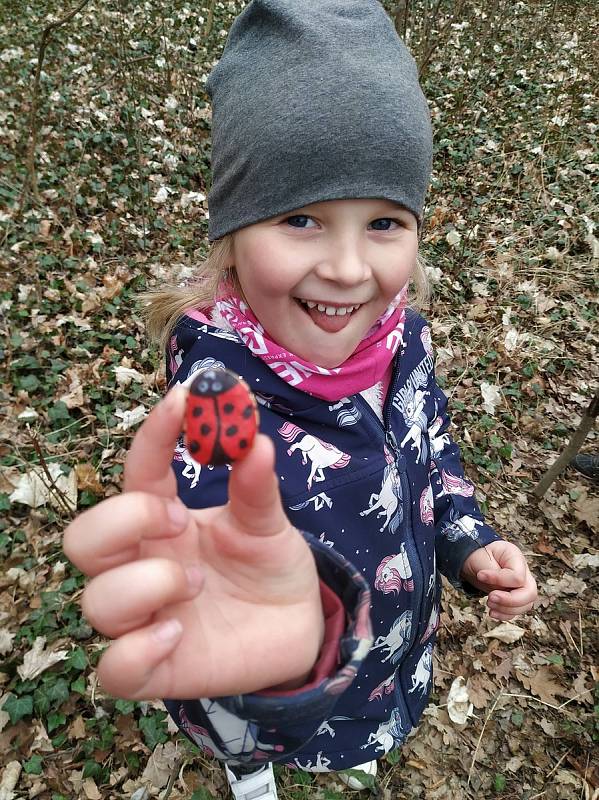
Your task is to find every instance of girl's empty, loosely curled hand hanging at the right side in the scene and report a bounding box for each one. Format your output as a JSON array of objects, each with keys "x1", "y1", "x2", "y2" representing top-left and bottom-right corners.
[{"x1": 461, "y1": 541, "x2": 537, "y2": 620}]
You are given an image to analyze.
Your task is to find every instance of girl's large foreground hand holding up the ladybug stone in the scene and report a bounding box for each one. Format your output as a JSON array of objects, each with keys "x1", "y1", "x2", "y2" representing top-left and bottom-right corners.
[{"x1": 64, "y1": 387, "x2": 324, "y2": 699}]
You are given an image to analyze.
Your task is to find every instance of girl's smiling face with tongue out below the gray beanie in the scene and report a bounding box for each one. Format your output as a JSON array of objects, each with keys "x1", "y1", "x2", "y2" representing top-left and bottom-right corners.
[{"x1": 233, "y1": 200, "x2": 418, "y2": 369}]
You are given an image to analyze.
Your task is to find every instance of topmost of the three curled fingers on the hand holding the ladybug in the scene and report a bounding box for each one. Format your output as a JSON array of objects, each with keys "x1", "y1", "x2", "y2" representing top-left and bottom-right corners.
[{"x1": 64, "y1": 492, "x2": 190, "y2": 577}]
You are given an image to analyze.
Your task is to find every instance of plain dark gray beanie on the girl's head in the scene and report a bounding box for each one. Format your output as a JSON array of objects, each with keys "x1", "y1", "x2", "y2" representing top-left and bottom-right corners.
[{"x1": 207, "y1": 0, "x2": 432, "y2": 241}]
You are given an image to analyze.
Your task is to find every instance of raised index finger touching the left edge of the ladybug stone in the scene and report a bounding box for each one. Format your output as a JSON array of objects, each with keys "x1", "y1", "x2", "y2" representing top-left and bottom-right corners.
[{"x1": 124, "y1": 386, "x2": 187, "y2": 497}]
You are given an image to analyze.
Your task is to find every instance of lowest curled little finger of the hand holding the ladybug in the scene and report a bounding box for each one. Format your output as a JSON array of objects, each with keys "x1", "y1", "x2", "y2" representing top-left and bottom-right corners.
[{"x1": 98, "y1": 619, "x2": 183, "y2": 700}]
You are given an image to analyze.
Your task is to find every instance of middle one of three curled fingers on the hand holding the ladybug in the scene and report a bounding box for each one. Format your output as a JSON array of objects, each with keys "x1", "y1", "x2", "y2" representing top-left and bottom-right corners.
[{"x1": 81, "y1": 558, "x2": 204, "y2": 638}]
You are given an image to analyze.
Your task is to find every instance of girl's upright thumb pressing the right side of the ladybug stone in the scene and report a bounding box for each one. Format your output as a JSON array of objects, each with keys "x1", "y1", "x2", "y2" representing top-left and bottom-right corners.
[{"x1": 229, "y1": 434, "x2": 289, "y2": 536}]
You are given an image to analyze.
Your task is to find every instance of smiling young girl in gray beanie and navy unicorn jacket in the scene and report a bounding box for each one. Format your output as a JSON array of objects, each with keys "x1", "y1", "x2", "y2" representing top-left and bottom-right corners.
[{"x1": 65, "y1": 0, "x2": 536, "y2": 800}]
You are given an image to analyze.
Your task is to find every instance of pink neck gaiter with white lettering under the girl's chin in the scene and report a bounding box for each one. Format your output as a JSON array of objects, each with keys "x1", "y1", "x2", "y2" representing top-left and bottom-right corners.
[{"x1": 215, "y1": 290, "x2": 406, "y2": 400}]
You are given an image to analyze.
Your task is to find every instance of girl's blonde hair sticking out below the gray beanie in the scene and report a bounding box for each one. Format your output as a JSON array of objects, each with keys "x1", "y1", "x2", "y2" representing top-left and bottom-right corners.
[{"x1": 140, "y1": 233, "x2": 430, "y2": 351}]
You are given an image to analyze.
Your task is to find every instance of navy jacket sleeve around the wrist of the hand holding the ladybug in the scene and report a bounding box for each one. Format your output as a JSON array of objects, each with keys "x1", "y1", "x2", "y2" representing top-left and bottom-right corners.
[{"x1": 165, "y1": 533, "x2": 372, "y2": 766}]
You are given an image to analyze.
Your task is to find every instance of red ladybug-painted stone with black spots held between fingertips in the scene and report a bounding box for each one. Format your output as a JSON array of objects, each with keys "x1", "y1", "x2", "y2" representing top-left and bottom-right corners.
[{"x1": 185, "y1": 368, "x2": 258, "y2": 466}]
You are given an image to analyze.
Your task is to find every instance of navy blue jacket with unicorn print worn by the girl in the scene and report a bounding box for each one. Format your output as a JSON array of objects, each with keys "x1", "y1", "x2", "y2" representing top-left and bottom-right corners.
[{"x1": 166, "y1": 311, "x2": 500, "y2": 770}]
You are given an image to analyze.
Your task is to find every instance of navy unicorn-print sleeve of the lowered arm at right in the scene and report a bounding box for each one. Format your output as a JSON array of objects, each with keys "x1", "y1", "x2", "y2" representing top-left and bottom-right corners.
[{"x1": 428, "y1": 377, "x2": 501, "y2": 593}]
